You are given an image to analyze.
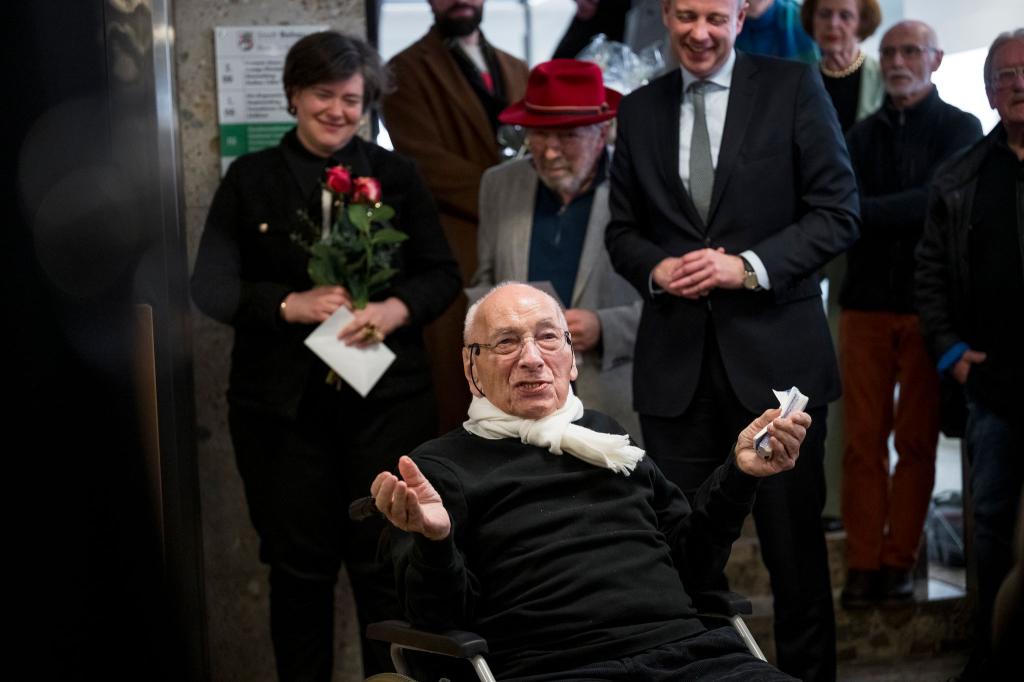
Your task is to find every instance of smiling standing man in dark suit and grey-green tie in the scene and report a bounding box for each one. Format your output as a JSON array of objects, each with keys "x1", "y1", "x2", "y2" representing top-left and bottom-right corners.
[{"x1": 606, "y1": 0, "x2": 858, "y2": 680}]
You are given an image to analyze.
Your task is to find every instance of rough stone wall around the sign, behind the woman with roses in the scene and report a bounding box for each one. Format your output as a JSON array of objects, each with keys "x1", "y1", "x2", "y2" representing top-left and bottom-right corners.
[{"x1": 173, "y1": 0, "x2": 366, "y2": 682}]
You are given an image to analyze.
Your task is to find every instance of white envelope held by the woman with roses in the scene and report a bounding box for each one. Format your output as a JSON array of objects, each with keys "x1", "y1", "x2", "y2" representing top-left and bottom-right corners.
[{"x1": 305, "y1": 307, "x2": 394, "y2": 397}]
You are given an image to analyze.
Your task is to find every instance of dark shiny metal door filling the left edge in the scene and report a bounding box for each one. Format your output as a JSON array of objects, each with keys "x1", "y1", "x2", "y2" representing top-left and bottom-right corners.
[{"x1": 6, "y1": 0, "x2": 208, "y2": 680}]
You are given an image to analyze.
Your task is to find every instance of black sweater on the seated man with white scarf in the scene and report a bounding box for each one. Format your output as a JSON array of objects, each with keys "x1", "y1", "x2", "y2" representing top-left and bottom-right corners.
[{"x1": 398, "y1": 405, "x2": 757, "y2": 678}]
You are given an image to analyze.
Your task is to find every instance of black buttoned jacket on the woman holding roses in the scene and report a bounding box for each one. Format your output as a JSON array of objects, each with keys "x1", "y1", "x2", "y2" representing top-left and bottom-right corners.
[{"x1": 191, "y1": 130, "x2": 461, "y2": 418}]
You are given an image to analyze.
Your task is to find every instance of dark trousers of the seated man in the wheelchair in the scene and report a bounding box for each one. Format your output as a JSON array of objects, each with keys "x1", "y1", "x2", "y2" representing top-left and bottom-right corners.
[{"x1": 511, "y1": 628, "x2": 793, "y2": 682}]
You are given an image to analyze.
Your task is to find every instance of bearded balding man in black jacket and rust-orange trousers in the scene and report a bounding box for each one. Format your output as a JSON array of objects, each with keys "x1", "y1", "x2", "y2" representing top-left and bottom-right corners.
[{"x1": 840, "y1": 22, "x2": 981, "y2": 608}]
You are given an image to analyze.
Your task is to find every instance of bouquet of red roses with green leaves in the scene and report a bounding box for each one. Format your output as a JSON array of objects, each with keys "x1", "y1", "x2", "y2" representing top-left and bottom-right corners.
[{"x1": 295, "y1": 166, "x2": 409, "y2": 308}]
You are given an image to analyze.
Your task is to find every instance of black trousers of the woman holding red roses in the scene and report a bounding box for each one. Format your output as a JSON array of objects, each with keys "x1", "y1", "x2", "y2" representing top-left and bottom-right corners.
[{"x1": 228, "y1": 377, "x2": 436, "y2": 682}]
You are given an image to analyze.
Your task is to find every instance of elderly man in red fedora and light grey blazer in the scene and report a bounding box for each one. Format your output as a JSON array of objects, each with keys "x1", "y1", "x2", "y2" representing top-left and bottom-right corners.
[{"x1": 473, "y1": 59, "x2": 640, "y2": 439}]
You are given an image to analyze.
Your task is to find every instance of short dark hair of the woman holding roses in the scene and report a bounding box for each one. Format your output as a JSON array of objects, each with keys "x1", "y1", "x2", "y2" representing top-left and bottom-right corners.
[{"x1": 282, "y1": 31, "x2": 392, "y2": 111}]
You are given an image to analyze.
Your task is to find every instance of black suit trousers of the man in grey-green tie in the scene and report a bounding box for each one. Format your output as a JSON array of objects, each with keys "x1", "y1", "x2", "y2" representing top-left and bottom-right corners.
[{"x1": 640, "y1": 324, "x2": 836, "y2": 682}]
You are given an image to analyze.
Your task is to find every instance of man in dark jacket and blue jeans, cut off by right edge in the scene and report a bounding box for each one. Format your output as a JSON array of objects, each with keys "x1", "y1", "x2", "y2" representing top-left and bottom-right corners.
[{"x1": 915, "y1": 29, "x2": 1024, "y2": 679}]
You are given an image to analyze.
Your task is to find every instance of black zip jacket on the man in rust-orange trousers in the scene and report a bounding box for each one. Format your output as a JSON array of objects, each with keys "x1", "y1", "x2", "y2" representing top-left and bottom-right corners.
[{"x1": 839, "y1": 87, "x2": 981, "y2": 313}]
